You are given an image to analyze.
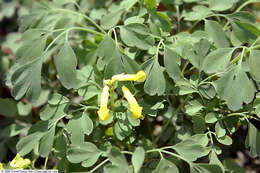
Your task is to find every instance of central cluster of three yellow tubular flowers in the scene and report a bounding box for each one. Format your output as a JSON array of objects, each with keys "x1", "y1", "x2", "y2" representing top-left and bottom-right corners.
[{"x1": 97, "y1": 71, "x2": 146, "y2": 121}]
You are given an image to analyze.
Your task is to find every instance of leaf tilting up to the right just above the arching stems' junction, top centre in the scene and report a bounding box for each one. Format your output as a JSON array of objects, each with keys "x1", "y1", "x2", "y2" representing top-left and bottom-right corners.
[{"x1": 100, "y1": 10, "x2": 123, "y2": 30}]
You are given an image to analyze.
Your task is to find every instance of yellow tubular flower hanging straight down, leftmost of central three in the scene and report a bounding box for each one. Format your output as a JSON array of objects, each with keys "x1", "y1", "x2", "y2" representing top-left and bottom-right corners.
[{"x1": 97, "y1": 85, "x2": 109, "y2": 121}]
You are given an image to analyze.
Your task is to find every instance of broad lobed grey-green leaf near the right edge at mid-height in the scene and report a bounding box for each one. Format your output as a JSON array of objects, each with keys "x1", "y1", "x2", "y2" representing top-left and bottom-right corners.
[{"x1": 216, "y1": 65, "x2": 255, "y2": 111}]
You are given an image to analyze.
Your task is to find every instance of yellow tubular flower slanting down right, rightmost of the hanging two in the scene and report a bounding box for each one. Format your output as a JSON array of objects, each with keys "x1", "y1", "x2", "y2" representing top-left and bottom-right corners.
[{"x1": 122, "y1": 86, "x2": 143, "y2": 119}]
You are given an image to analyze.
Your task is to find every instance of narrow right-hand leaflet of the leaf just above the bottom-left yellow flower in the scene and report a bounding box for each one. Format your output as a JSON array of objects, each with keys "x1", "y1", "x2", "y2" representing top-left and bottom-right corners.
[{"x1": 39, "y1": 126, "x2": 55, "y2": 157}]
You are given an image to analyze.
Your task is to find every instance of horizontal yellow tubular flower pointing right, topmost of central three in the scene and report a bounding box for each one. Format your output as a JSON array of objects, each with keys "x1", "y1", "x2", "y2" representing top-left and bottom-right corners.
[{"x1": 108, "y1": 71, "x2": 146, "y2": 83}]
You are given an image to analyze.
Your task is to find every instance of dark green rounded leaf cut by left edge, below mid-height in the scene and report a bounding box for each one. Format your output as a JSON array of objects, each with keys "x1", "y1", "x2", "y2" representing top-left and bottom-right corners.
[{"x1": 0, "y1": 98, "x2": 17, "y2": 117}]
